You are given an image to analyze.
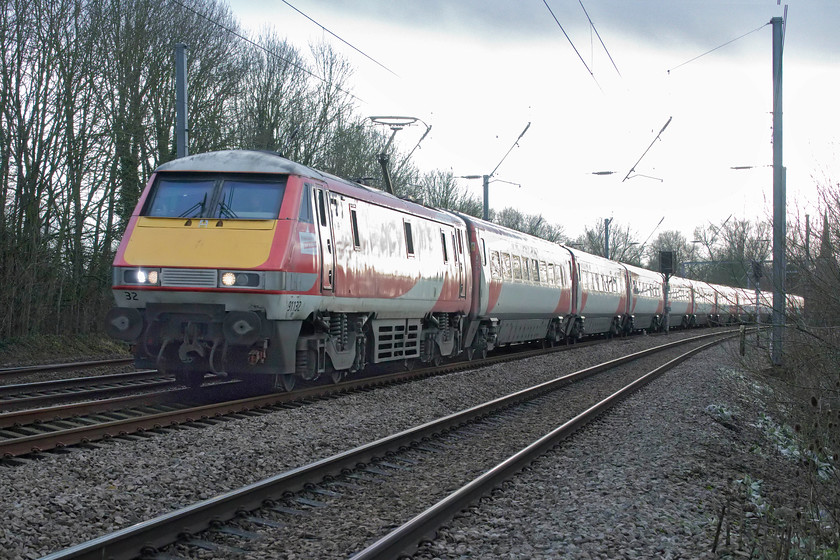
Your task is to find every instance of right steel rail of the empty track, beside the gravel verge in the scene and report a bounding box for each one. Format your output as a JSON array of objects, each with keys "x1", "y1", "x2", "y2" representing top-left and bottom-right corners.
[{"x1": 350, "y1": 335, "x2": 735, "y2": 560}]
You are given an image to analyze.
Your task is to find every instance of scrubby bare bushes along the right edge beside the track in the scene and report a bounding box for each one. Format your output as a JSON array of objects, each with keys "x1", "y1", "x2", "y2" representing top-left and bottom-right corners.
[{"x1": 719, "y1": 178, "x2": 840, "y2": 559}]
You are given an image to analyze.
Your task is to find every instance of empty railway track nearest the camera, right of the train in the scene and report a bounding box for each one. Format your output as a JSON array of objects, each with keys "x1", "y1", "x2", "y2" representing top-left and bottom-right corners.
[{"x1": 39, "y1": 333, "x2": 736, "y2": 560}]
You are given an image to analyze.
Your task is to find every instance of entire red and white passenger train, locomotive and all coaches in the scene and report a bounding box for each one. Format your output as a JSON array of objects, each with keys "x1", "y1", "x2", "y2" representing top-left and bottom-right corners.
[{"x1": 105, "y1": 150, "x2": 800, "y2": 390}]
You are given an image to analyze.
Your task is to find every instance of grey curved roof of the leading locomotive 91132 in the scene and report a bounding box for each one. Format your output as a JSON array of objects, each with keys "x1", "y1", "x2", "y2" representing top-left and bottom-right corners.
[{"x1": 155, "y1": 150, "x2": 463, "y2": 225}]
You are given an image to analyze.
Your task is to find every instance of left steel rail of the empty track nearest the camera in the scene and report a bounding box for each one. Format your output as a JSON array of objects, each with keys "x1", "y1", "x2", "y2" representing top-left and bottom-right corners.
[{"x1": 41, "y1": 331, "x2": 731, "y2": 560}]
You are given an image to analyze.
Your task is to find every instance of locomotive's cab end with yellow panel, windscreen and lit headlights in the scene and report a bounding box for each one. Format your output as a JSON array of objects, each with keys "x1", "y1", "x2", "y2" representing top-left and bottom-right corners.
[{"x1": 106, "y1": 152, "x2": 319, "y2": 385}]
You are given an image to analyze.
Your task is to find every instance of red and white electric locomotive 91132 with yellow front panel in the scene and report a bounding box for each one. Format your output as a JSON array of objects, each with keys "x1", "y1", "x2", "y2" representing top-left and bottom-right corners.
[{"x1": 106, "y1": 150, "x2": 472, "y2": 389}]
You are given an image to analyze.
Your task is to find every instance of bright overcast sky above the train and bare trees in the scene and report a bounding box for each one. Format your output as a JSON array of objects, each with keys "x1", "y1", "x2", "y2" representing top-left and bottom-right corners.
[{"x1": 230, "y1": 0, "x2": 840, "y2": 240}]
